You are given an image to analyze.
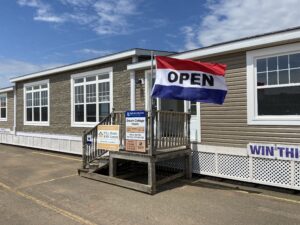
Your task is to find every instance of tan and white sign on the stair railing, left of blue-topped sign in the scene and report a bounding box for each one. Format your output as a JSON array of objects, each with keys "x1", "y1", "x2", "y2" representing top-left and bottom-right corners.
[{"x1": 97, "y1": 125, "x2": 120, "y2": 151}]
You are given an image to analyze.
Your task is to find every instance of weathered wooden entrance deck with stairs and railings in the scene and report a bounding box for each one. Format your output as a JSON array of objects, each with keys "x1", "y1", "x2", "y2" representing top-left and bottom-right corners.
[{"x1": 78, "y1": 111, "x2": 192, "y2": 194}]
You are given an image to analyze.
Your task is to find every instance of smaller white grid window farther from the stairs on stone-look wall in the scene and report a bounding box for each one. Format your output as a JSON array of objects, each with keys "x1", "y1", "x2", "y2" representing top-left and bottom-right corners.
[{"x1": 24, "y1": 80, "x2": 49, "y2": 126}]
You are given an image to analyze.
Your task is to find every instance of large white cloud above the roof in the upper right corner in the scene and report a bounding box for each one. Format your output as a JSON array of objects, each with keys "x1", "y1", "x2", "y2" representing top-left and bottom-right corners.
[{"x1": 185, "y1": 0, "x2": 300, "y2": 48}]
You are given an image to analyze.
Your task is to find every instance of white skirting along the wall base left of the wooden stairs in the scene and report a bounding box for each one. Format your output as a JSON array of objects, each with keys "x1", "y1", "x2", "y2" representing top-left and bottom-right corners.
[{"x1": 0, "y1": 133, "x2": 82, "y2": 155}]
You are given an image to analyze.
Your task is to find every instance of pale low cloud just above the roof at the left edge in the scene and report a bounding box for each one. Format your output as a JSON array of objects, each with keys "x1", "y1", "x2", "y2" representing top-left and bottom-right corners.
[{"x1": 0, "y1": 59, "x2": 61, "y2": 87}]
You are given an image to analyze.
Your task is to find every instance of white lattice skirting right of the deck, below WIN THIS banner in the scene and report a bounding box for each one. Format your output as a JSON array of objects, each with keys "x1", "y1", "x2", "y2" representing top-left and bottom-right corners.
[{"x1": 192, "y1": 144, "x2": 300, "y2": 190}]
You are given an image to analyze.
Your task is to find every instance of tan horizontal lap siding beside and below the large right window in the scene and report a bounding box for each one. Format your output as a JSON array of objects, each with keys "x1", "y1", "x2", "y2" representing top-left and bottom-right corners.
[{"x1": 200, "y1": 52, "x2": 300, "y2": 148}]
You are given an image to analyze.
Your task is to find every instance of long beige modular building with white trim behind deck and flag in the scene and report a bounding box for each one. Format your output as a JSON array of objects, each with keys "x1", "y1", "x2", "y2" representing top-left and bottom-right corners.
[{"x1": 0, "y1": 28, "x2": 300, "y2": 190}]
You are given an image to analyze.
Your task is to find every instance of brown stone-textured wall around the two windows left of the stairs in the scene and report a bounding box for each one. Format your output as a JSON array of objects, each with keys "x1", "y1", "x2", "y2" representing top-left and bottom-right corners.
[{"x1": 16, "y1": 58, "x2": 132, "y2": 135}]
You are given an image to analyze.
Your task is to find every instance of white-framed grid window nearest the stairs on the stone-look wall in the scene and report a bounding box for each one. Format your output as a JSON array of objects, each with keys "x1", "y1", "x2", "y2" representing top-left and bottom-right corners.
[{"x1": 72, "y1": 68, "x2": 112, "y2": 126}]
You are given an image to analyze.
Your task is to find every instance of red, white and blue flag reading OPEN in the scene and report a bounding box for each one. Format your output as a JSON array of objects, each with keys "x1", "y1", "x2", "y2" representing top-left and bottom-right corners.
[{"x1": 152, "y1": 56, "x2": 227, "y2": 104}]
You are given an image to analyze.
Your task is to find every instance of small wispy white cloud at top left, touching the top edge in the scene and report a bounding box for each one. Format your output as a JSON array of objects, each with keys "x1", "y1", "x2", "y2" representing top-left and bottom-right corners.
[{"x1": 18, "y1": 0, "x2": 64, "y2": 23}]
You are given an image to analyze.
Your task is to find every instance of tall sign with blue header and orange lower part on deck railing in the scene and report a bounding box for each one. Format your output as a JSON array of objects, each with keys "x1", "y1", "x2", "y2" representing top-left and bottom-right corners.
[{"x1": 126, "y1": 111, "x2": 146, "y2": 152}]
